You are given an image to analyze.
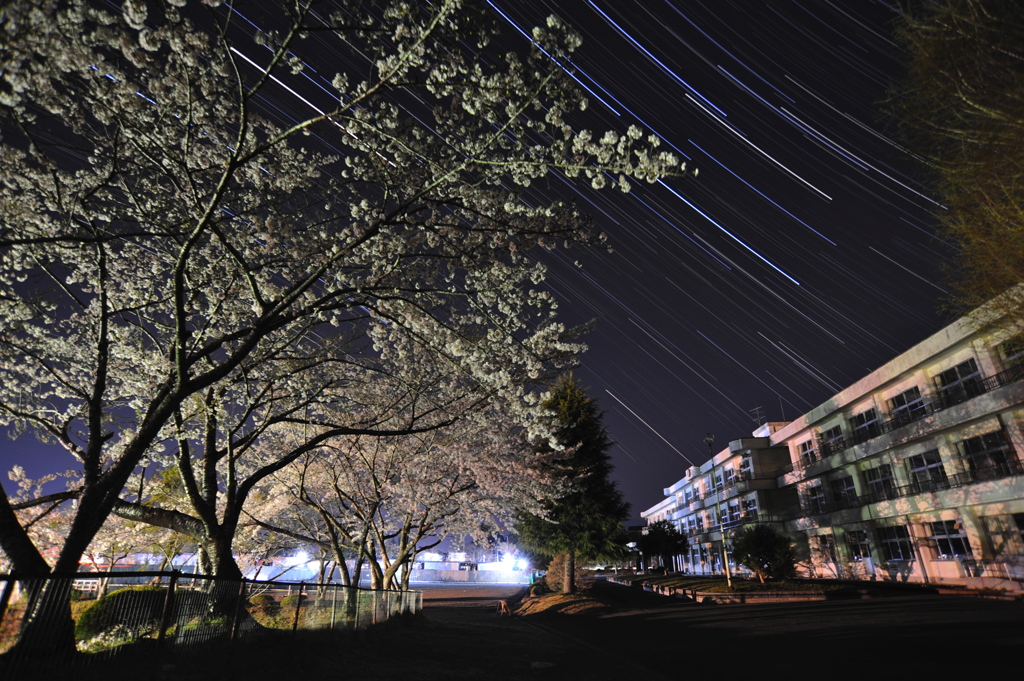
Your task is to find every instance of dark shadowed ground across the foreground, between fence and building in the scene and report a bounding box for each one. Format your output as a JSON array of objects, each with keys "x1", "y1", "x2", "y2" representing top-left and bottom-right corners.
[{"x1": 4, "y1": 582, "x2": 1024, "y2": 681}]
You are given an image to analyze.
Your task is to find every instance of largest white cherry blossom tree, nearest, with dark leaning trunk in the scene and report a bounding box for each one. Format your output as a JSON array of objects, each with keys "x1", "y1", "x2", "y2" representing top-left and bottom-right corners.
[{"x1": 0, "y1": 0, "x2": 678, "y2": 649}]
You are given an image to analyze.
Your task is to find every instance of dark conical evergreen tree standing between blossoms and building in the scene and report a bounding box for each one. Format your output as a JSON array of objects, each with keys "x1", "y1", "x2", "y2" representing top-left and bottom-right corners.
[{"x1": 517, "y1": 377, "x2": 630, "y2": 594}]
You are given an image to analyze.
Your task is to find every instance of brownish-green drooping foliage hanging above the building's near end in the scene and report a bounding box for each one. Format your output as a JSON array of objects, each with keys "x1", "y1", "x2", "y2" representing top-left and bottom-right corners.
[{"x1": 891, "y1": 0, "x2": 1024, "y2": 324}]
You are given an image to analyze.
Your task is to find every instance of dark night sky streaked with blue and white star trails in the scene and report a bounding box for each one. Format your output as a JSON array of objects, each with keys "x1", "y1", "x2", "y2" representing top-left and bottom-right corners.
[{"x1": 0, "y1": 0, "x2": 950, "y2": 518}]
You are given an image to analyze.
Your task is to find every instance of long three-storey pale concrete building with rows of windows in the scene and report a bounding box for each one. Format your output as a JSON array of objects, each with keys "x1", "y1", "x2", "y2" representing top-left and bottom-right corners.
[{"x1": 641, "y1": 303, "x2": 1024, "y2": 588}]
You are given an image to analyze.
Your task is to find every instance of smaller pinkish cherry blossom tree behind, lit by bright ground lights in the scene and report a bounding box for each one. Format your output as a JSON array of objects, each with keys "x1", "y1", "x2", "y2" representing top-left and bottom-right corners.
[{"x1": 250, "y1": 403, "x2": 555, "y2": 589}]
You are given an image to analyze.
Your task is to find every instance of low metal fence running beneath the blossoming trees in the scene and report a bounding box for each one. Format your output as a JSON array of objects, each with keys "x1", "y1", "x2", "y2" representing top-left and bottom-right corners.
[{"x1": 0, "y1": 571, "x2": 423, "y2": 679}]
